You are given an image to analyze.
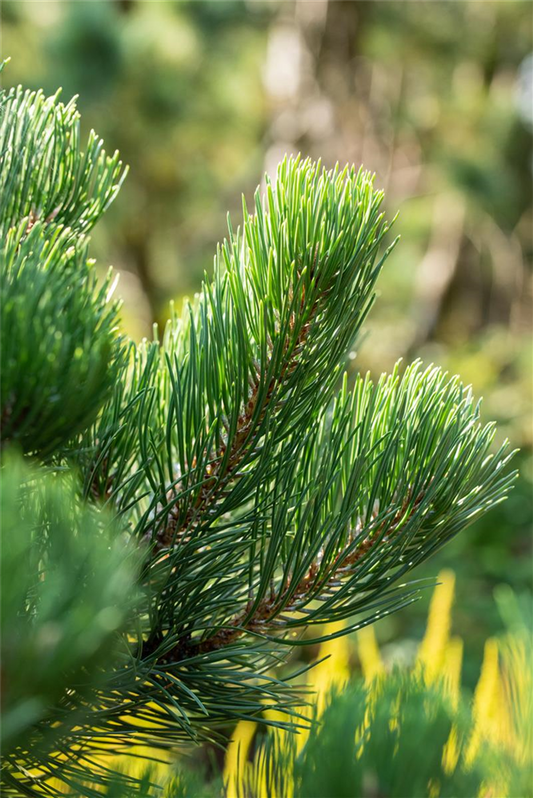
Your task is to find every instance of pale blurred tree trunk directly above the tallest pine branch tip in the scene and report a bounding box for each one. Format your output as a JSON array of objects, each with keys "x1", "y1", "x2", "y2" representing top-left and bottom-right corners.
[{"x1": 265, "y1": 0, "x2": 372, "y2": 171}]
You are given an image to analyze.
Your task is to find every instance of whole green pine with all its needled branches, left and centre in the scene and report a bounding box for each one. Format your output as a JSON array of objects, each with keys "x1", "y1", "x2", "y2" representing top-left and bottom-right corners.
[{"x1": 0, "y1": 72, "x2": 514, "y2": 796}]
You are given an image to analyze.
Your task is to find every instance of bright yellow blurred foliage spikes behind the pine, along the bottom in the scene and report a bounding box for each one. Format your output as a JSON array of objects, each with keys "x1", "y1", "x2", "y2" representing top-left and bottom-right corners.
[{"x1": 45, "y1": 571, "x2": 533, "y2": 798}]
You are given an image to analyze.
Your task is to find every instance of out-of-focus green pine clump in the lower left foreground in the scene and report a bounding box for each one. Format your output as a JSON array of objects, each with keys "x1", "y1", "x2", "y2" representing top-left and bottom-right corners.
[{"x1": 0, "y1": 452, "x2": 138, "y2": 760}]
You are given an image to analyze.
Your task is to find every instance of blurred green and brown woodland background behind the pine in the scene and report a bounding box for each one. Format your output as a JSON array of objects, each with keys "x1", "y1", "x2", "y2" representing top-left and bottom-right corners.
[{"x1": 1, "y1": 0, "x2": 533, "y2": 685}]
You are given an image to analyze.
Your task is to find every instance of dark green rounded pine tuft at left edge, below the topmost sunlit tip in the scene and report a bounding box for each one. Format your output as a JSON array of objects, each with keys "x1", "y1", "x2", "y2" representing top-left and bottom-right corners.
[{"x1": 0, "y1": 221, "x2": 122, "y2": 456}]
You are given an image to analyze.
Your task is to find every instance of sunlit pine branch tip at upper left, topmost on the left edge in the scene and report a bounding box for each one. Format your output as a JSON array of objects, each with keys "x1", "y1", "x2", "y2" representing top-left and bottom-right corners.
[{"x1": 0, "y1": 86, "x2": 126, "y2": 237}]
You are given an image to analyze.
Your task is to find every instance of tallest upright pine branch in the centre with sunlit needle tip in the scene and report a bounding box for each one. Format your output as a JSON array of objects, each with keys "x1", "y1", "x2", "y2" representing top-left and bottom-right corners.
[{"x1": 139, "y1": 161, "x2": 387, "y2": 551}]
